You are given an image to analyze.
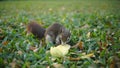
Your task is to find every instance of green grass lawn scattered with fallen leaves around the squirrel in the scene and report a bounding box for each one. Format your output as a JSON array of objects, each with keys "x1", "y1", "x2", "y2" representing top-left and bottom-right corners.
[{"x1": 0, "y1": 0, "x2": 120, "y2": 68}]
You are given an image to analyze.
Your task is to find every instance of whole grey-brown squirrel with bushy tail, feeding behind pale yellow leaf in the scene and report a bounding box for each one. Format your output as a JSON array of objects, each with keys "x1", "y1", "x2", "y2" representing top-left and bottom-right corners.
[{"x1": 27, "y1": 22, "x2": 71, "y2": 45}]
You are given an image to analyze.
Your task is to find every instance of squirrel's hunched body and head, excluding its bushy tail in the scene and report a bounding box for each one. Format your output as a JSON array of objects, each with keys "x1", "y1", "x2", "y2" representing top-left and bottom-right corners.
[{"x1": 45, "y1": 23, "x2": 71, "y2": 44}]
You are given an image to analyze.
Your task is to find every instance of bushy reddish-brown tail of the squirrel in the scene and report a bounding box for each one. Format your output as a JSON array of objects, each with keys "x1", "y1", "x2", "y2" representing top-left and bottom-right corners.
[{"x1": 27, "y1": 21, "x2": 46, "y2": 40}]
